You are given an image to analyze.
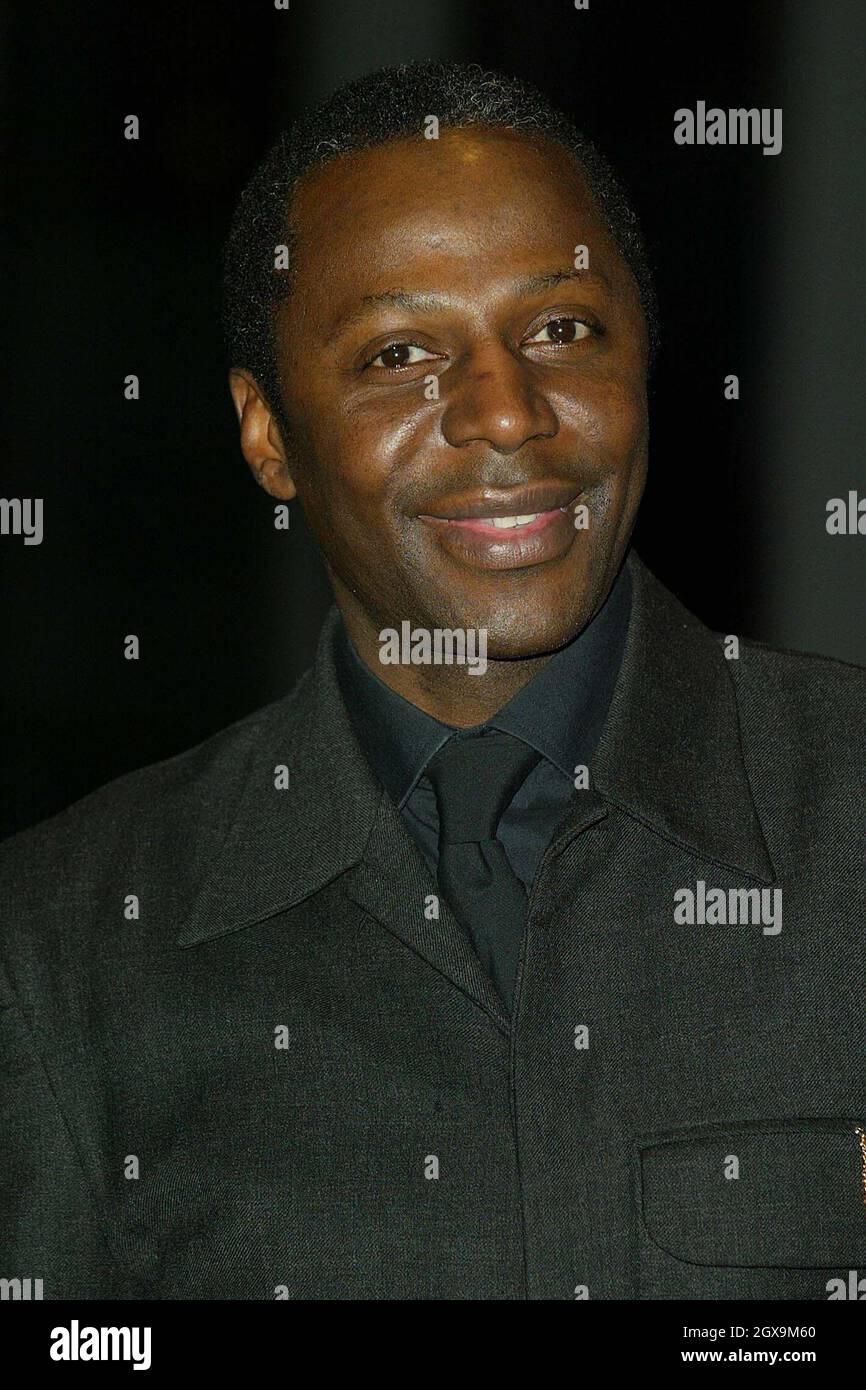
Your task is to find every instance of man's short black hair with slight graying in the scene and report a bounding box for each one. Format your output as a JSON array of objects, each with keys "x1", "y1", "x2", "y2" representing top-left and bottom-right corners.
[{"x1": 222, "y1": 63, "x2": 659, "y2": 424}]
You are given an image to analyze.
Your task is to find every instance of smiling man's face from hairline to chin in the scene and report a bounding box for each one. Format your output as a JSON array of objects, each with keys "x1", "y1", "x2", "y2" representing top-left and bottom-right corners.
[{"x1": 268, "y1": 129, "x2": 648, "y2": 660}]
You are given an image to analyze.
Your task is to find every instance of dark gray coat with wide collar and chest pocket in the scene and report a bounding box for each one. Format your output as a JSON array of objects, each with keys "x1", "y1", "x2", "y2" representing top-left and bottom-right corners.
[{"x1": 0, "y1": 555, "x2": 866, "y2": 1300}]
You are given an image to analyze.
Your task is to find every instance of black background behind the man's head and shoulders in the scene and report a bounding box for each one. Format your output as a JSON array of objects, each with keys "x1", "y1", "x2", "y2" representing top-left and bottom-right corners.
[{"x1": 0, "y1": 0, "x2": 866, "y2": 833}]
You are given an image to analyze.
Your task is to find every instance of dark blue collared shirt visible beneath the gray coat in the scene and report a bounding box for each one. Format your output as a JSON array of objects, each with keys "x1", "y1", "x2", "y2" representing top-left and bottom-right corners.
[{"x1": 335, "y1": 566, "x2": 631, "y2": 892}]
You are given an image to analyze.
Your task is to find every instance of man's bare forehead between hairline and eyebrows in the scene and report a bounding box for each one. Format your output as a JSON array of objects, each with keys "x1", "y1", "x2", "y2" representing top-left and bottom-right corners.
[{"x1": 292, "y1": 131, "x2": 617, "y2": 307}]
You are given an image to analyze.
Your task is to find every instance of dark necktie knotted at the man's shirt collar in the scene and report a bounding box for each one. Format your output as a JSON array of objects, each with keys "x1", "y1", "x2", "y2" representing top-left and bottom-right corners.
[{"x1": 427, "y1": 733, "x2": 541, "y2": 1008}]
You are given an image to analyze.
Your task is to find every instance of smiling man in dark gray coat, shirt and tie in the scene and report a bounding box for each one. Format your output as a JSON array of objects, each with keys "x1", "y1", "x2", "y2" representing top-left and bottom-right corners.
[{"x1": 1, "y1": 65, "x2": 866, "y2": 1300}]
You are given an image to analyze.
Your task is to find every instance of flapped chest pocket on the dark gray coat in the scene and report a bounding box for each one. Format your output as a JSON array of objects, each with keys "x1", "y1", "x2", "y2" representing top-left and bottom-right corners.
[{"x1": 638, "y1": 1118, "x2": 866, "y2": 1298}]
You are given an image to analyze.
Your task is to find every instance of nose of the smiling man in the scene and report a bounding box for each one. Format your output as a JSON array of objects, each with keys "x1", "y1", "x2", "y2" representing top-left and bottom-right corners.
[{"x1": 442, "y1": 345, "x2": 559, "y2": 453}]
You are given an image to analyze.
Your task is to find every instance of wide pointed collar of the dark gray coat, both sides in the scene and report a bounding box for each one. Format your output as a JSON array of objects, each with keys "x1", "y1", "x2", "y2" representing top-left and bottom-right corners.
[{"x1": 177, "y1": 552, "x2": 774, "y2": 956}]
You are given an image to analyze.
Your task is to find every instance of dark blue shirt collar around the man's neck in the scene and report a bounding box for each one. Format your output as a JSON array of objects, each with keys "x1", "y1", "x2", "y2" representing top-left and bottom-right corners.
[{"x1": 334, "y1": 566, "x2": 631, "y2": 809}]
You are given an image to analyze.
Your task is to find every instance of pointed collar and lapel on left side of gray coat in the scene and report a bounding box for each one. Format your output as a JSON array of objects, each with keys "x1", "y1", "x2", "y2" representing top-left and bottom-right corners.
[{"x1": 177, "y1": 610, "x2": 507, "y2": 1029}]
